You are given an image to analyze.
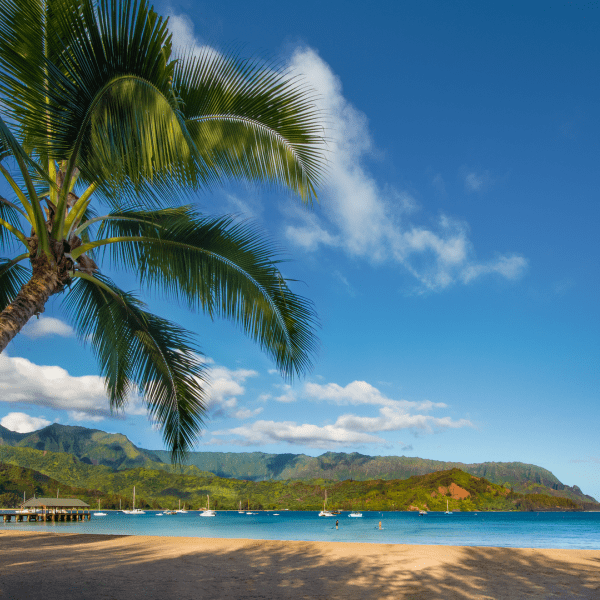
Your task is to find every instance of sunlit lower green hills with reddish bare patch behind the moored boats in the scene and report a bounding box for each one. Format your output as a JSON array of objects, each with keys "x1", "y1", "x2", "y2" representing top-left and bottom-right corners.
[{"x1": 0, "y1": 446, "x2": 598, "y2": 511}]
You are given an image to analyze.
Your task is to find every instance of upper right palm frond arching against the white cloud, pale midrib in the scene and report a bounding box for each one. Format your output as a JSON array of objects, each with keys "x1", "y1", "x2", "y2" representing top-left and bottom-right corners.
[{"x1": 174, "y1": 48, "x2": 325, "y2": 203}]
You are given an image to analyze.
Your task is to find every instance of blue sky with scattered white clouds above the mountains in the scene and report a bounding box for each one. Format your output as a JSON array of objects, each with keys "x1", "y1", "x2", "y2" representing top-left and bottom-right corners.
[{"x1": 0, "y1": 2, "x2": 600, "y2": 500}]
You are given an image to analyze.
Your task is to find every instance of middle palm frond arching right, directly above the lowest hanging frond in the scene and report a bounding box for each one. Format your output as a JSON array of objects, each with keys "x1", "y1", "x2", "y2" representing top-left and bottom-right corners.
[{"x1": 93, "y1": 207, "x2": 318, "y2": 378}]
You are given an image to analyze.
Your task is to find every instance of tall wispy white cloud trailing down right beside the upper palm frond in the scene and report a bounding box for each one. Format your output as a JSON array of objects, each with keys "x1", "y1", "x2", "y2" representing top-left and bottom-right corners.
[{"x1": 285, "y1": 48, "x2": 527, "y2": 290}]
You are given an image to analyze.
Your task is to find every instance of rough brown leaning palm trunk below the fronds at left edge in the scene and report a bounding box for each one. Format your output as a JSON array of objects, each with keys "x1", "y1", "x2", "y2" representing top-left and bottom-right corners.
[{"x1": 0, "y1": 269, "x2": 62, "y2": 353}]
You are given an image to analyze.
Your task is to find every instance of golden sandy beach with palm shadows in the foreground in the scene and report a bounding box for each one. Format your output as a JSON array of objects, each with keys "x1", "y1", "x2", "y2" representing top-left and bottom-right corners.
[{"x1": 0, "y1": 527, "x2": 600, "y2": 600}]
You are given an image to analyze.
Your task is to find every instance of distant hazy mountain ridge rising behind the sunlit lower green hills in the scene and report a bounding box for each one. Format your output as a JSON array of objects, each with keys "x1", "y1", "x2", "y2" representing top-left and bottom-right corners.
[{"x1": 0, "y1": 424, "x2": 595, "y2": 502}]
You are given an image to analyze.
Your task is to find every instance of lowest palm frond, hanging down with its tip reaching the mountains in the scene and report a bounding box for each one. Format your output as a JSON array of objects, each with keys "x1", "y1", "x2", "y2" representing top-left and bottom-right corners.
[{"x1": 63, "y1": 274, "x2": 205, "y2": 462}]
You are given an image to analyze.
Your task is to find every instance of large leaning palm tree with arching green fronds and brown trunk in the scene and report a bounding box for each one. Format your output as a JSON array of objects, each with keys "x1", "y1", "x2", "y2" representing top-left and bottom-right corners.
[{"x1": 0, "y1": 0, "x2": 324, "y2": 461}]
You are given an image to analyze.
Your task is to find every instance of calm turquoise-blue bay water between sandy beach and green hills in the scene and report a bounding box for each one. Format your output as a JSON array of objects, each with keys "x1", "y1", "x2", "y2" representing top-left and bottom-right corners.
[{"x1": 0, "y1": 511, "x2": 600, "y2": 550}]
